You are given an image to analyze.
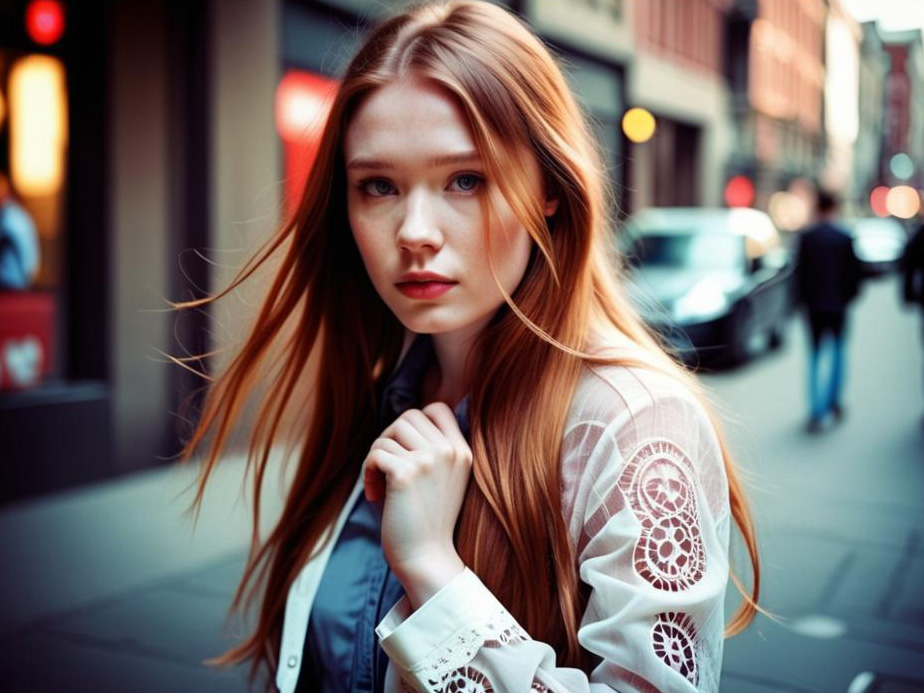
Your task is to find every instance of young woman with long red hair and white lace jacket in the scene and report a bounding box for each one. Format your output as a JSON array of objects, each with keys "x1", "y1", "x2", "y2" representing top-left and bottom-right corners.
[{"x1": 180, "y1": 0, "x2": 759, "y2": 693}]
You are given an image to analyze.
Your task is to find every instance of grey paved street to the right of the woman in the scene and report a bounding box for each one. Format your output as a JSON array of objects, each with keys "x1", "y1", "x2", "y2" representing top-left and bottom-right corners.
[{"x1": 704, "y1": 278, "x2": 924, "y2": 693}]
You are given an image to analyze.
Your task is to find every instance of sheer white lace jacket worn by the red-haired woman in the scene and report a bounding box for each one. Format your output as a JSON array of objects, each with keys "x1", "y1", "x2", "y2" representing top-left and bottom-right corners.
[{"x1": 276, "y1": 356, "x2": 730, "y2": 693}]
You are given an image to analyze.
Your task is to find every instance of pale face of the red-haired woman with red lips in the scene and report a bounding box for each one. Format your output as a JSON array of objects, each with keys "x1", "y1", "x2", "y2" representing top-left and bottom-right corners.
[{"x1": 344, "y1": 78, "x2": 542, "y2": 336}]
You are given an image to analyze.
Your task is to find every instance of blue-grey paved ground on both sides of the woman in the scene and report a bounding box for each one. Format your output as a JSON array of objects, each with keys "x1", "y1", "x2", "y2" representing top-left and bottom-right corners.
[{"x1": 0, "y1": 279, "x2": 924, "y2": 693}]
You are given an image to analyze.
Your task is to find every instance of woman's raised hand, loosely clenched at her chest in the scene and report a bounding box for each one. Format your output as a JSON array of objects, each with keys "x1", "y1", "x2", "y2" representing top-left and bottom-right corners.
[{"x1": 363, "y1": 402, "x2": 472, "y2": 608}]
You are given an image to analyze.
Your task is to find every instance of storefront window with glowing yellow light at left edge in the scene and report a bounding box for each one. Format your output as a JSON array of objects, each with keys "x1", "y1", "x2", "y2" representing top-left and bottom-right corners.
[{"x1": 0, "y1": 24, "x2": 68, "y2": 390}]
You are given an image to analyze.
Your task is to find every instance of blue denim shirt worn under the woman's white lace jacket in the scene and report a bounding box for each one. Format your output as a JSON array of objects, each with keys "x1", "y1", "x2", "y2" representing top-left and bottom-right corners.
[{"x1": 296, "y1": 334, "x2": 468, "y2": 693}]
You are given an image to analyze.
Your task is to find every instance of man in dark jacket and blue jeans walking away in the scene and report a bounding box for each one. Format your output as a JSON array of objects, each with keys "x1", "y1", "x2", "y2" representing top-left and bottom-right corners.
[{"x1": 796, "y1": 190, "x2": 861, "y2": 433}]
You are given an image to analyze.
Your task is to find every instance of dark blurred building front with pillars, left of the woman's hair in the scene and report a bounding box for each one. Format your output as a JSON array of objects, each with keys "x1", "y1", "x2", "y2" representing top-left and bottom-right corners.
[{"x1": 0, "y1": 0, "x2": 280, "y2": 502}]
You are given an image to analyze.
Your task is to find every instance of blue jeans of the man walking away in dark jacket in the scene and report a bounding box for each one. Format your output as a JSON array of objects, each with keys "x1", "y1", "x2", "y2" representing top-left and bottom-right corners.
[{"x1": 809, "y1": 311, "x2": 845, "y2": 421}]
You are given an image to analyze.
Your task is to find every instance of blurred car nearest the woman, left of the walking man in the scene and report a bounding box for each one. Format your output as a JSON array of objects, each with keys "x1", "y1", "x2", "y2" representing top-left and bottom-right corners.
[{"x1": 622, "y1": 207, "x2": 794, "y2": 364}]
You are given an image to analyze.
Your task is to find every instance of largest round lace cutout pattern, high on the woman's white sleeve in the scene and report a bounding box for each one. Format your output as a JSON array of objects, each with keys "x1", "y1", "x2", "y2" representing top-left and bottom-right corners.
[{"x1": 619, "y1": 440, "x2": 706, "y2": 592}]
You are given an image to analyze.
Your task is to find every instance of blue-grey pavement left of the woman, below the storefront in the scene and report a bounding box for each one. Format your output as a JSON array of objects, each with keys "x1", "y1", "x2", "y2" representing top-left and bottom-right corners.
[{"x1": 0, "y1": 448, "x2": 279, "y2": 693}]
